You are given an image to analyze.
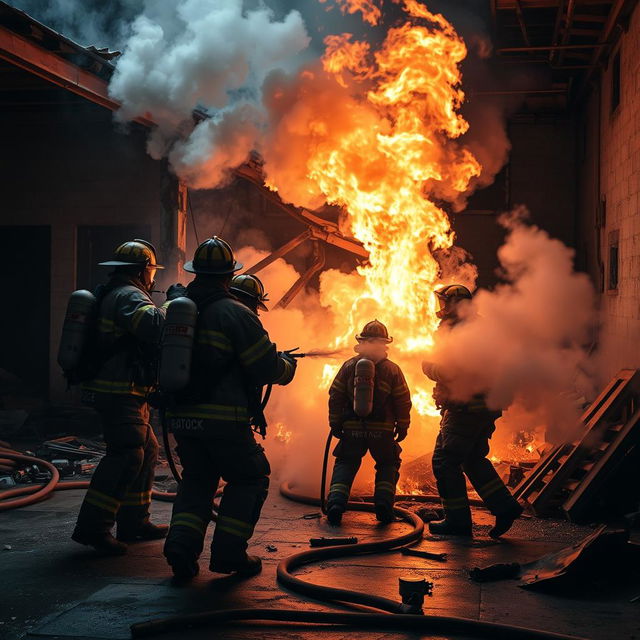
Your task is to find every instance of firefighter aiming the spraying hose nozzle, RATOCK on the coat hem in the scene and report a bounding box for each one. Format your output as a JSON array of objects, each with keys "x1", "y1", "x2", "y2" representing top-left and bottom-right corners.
[{"x1": 164, "y1": 237, "x2": 296, "y2": 582}]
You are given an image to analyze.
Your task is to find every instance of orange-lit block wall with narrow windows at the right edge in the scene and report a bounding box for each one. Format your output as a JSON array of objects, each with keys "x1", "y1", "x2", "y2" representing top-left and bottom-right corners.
[{"x1": 600, "y1": 3, "x2": 640, "y2": 377}]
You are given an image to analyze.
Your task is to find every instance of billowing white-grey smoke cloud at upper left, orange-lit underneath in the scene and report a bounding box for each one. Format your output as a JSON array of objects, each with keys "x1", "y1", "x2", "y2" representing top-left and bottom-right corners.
[{"x1": 109, "y1": 0, "x2": 309, "y2": 187}]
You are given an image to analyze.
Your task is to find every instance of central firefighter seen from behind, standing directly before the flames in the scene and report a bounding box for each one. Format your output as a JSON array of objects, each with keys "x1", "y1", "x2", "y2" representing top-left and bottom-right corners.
[{"x1": 327, "y1": 320, "x2": 411, "y2": 526}]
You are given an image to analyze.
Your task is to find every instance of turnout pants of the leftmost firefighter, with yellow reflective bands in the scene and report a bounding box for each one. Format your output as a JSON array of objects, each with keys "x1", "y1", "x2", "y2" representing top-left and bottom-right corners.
[{"x1": 76, "y1": 394, "x2": 158, "y2": 534}]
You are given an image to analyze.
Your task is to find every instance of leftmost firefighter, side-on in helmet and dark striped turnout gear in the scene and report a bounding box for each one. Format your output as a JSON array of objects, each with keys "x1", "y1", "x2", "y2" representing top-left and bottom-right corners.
[{"x1": 71, "y1": 239, "x2": 186, "y2": 554}]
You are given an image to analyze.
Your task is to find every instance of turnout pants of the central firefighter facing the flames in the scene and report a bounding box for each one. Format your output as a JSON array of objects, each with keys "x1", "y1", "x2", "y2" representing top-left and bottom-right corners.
[{"x1": 327, "y1": 430, "x2": 402, "y2": 510}]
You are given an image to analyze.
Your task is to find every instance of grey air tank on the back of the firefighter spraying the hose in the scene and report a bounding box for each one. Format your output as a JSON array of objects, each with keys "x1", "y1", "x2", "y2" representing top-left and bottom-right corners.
[{"x1": 159, "y1": 297, "x2": 198, "y2": 393}]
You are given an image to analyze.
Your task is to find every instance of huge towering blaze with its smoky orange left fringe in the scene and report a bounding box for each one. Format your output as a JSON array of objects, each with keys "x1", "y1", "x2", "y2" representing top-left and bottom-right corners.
[{"x1": 266, "y1": 0, "x2": 480, "y2": 424}]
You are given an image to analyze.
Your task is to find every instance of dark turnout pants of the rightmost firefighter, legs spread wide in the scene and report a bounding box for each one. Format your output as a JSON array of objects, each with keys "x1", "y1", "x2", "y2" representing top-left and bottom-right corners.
[{"x1": 433, "y1": 410, "x2": 518, "y2": 525}]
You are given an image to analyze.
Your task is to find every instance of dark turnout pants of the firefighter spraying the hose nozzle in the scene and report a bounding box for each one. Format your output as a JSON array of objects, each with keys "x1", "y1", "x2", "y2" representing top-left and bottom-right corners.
[{"x1": 164, "y1": 427, "x2": 271, "y2": 565}]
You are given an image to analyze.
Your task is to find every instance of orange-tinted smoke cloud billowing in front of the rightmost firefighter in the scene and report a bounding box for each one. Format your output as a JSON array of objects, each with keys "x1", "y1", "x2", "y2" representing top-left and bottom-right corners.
[{"x1": 427, "y1": 208, "x2": 598, "y2": 444}]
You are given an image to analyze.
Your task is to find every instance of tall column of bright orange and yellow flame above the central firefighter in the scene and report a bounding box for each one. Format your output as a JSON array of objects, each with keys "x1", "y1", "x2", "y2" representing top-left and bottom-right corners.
[{"x1": 318, "y1": 2, "x2": 480, "y2": 415}]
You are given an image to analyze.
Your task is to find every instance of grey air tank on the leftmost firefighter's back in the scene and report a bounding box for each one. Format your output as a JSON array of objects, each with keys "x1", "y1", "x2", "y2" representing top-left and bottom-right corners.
[{"x1": 58, "y1": 289, "x2": 97, "y2": 372}]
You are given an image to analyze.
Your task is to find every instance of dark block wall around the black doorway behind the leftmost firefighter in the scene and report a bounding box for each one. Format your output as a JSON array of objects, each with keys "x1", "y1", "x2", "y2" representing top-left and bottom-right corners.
[{"x1": 0, "y1": 103, "x2": 166, "y2": 404}]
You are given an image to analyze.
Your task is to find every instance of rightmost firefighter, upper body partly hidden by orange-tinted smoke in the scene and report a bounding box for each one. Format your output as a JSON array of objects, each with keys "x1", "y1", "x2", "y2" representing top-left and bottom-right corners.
[{"x1": 422, "y1": 284, "x2": 522, "y2": 538}]
